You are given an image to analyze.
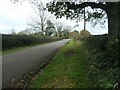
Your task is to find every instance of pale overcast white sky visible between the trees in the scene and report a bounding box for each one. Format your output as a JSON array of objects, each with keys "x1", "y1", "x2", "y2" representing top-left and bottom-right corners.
[{"x1": 0, "y1": 0, "x2": 108, "y2": 35}]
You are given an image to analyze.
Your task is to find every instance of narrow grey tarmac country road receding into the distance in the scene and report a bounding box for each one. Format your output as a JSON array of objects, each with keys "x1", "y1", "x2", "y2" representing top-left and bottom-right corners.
[{"x1": 2, "y1": 39, "x2": 70, "y2": 88}]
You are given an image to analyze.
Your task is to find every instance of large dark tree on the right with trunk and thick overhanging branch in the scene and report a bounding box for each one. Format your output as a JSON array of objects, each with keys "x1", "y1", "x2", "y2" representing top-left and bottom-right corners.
[{"x1": 47, "y1": 0, "x2": 120, "y2": 38}]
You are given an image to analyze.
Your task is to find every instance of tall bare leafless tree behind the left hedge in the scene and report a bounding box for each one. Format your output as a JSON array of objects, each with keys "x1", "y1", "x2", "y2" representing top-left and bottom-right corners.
[{"x1": 28, "y1": 0, "x2": 50, "y2": 35}]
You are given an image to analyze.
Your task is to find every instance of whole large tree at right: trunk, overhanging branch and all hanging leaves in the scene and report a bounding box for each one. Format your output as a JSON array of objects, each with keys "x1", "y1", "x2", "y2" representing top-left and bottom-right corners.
[{"x1": 47, "y1": 0, "x2": 120, "y2": 51}]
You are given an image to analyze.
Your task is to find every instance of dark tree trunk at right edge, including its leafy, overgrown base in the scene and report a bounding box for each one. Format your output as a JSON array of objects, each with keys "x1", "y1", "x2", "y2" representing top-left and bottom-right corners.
[{"x1": 107, "y1": 2, "x2": 120, "y2": 66}]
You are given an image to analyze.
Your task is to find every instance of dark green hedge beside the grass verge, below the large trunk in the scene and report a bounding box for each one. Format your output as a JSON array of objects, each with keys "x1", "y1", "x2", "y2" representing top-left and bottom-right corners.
[{"x1": 85, "y1": 35, "x2": 120, "y2": 88}]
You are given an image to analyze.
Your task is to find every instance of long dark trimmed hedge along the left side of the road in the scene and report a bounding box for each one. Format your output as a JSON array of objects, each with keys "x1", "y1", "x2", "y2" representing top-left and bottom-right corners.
[{"x1": 2, "y1": 34, "x2": 61, "y2": 50}]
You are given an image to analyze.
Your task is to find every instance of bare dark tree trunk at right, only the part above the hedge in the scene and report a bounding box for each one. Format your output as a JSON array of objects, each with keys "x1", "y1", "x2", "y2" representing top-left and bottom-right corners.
[{"x1": 106, "y1": 2, "x2": 120, "y2": 40}]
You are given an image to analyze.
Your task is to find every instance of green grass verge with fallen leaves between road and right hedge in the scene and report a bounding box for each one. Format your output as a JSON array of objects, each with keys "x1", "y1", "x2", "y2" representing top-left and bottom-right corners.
[{"x1": 29, "y1": 40, "x2": 93, "y2": 88}]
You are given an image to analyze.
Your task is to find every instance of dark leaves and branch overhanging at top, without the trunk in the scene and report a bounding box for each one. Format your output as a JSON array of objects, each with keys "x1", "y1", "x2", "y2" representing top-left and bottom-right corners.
[{"x1": 47, "y1": 0, "x2": 107, "y2": 27}]
